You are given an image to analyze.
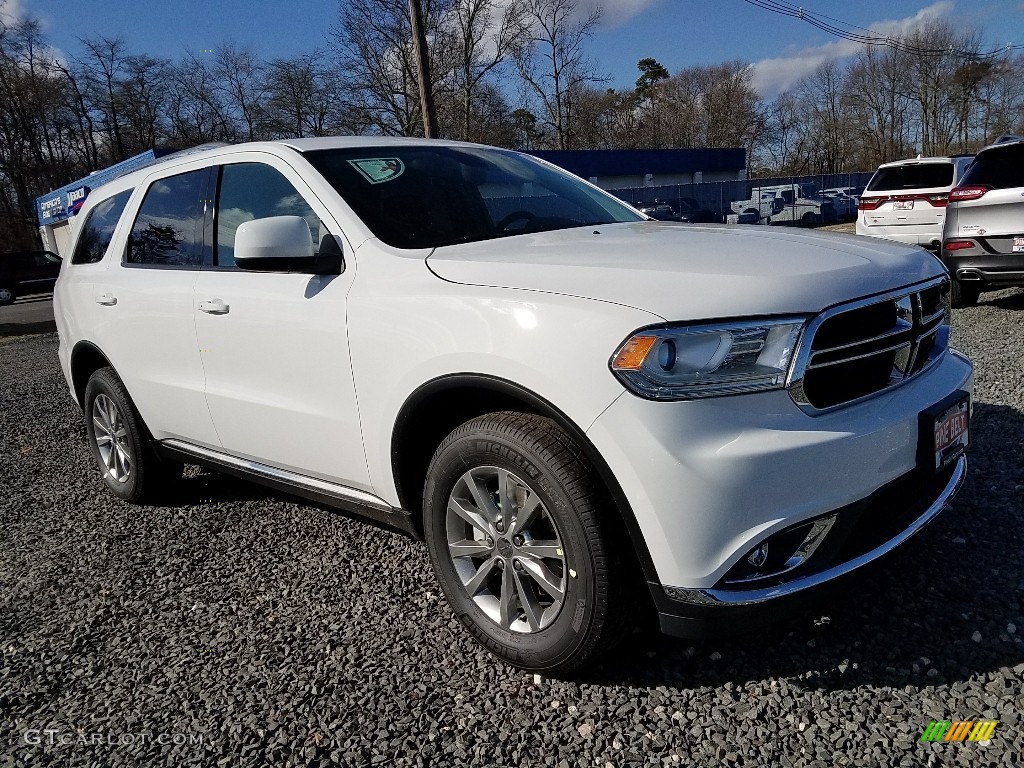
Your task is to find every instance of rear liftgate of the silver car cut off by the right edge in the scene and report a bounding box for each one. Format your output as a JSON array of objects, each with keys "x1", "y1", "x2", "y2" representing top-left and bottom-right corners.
[{"x1": 947, "y1": 143, "x2": 1024, "y2": 253}]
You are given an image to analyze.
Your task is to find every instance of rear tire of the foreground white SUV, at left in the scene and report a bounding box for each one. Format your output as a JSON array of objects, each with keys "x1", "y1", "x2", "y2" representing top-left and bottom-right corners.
[{"x1": 84, "y1": 368, "x2": 184, "y2": 504}]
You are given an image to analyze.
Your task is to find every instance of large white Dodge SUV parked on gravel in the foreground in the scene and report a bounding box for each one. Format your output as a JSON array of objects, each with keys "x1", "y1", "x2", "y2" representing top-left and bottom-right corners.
[{"x1": 54, "y1": 137, "x2": 972, "y2": 672}]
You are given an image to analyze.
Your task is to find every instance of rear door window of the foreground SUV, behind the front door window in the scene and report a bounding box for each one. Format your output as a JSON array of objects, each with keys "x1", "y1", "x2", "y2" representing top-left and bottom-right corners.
[{"x1": 125, "y1": 169, "x2": 209, "y2": 267}]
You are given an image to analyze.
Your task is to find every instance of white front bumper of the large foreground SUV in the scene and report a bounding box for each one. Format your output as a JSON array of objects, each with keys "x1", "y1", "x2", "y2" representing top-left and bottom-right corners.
[{"x1": 588, "y1": 352, "x2": 973, "y2": 638}]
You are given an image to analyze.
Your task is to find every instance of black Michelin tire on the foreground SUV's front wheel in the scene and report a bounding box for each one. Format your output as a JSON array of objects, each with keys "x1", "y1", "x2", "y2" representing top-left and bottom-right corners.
[{"x1": 423, "y1": 412, "x2": 637, "y2": 674}]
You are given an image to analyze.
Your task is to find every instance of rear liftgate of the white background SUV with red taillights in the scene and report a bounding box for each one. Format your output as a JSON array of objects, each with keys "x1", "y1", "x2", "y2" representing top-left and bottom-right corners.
[{"x1": 861, "y1": 161, "x2": 953, "y2": 232}]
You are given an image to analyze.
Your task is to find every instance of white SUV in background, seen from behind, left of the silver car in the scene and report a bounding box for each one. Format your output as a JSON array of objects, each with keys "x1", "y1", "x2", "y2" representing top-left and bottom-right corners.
[{"x1": 857, "y1": 155, "x2": 972, "y2": 251}]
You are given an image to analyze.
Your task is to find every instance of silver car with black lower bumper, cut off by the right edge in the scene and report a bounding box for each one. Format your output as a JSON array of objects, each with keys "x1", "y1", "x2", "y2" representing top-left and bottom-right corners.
[{"x1": 941, "y1": 136, "x2": 1024, "y2": 306}]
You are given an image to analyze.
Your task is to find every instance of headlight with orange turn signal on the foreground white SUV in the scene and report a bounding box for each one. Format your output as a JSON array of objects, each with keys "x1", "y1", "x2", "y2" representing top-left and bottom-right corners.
[{"x1": 609, "y1": 317, "x2": 804, "y2": 400}]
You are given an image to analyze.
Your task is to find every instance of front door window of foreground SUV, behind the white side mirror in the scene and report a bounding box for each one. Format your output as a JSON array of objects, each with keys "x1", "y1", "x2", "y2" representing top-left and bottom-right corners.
[{"x1": 214, "y1": 163, "x2": 328, "y2": 266}]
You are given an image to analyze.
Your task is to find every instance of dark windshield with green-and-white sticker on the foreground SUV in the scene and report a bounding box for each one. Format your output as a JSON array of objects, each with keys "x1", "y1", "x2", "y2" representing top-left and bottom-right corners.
[{"x1": 304, "y1": 145, "x2": 644, "y2": 248}]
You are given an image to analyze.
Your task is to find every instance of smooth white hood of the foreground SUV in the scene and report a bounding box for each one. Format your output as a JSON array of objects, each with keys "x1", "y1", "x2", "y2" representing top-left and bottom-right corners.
[{"x1": 427, "y1": 221, "x2": 943, "y2": 321}]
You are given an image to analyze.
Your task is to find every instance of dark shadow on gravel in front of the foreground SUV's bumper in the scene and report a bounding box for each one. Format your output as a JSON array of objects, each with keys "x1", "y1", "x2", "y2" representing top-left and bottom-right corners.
[{"x1": 580, "y1": 403, "x2": 1024, "y2": 695}]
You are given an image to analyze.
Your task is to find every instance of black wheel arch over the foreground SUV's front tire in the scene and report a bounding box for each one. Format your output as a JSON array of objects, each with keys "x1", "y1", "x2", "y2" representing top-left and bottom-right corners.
[{"x1": 391, "y1": 373, "x2": 657, "y2": 582}]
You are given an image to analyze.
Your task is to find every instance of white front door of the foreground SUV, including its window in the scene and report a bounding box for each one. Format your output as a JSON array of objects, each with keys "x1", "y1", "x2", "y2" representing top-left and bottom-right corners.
[{"x1": 195, "y1": 155, "x2": 372, "y2": 490}]
